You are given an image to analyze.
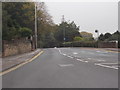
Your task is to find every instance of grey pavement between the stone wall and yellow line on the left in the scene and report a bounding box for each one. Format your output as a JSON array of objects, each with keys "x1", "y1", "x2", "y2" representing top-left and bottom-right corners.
[{"x1": 0, "y1": 49, "x2": 41, "y2": 71}]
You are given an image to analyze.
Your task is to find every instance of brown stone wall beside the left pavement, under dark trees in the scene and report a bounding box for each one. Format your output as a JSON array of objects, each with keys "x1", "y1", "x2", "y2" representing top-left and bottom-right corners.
[{"x1": 3, "y1": 40, "x2": 31, "y2": 57}]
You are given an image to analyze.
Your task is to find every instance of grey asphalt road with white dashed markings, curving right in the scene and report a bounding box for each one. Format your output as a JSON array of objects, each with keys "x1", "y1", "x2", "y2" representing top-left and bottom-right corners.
[{"x1": 2, "y1": 48, "x2": 118, "y2": 88}]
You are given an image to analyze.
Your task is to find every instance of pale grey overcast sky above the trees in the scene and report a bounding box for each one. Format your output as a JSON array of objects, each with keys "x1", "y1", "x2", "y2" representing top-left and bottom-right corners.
[{"x1": 45, "y1": 2, "x2": 118, "y2": 36}]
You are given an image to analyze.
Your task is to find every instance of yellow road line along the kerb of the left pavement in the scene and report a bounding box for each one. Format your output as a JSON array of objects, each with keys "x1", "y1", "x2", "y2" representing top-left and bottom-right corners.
[{"x1": 0, "y1": 51, "x2": 44, "y2": 76}]
